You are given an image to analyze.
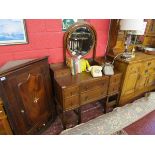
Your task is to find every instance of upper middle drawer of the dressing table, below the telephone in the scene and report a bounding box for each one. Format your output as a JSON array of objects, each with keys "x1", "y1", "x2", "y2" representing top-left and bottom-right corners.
[{"x1": 80, "y1": 78, "x2": 108, "y2": 92}]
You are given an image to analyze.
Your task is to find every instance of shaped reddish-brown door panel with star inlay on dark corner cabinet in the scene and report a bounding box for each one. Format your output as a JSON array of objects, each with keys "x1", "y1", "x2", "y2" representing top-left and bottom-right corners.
[{"x1": 18, "y1": 74, "x2": 48, "y2": 124}]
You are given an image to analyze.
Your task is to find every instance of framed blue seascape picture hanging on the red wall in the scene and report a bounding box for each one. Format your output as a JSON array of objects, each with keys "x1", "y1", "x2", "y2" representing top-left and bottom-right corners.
[{"x1": 0, "y1": 19, "x2": 28, "y2": 45}]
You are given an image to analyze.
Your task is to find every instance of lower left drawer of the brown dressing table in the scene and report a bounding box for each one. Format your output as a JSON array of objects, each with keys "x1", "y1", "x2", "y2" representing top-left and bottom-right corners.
[{"x1": 63, "y1": 95, "x2": 79, "y2": 111}]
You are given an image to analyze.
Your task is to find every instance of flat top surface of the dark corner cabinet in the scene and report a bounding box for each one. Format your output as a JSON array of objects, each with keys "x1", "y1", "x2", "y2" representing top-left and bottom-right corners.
[{"x1": 0, "y1": 57, "x2": 48, "y2": 76}]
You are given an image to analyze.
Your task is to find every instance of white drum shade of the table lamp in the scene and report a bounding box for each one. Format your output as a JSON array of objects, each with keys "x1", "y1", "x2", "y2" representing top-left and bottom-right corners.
[{"x1": 120, "y1": 19, "x2": 144, "y2": 31}]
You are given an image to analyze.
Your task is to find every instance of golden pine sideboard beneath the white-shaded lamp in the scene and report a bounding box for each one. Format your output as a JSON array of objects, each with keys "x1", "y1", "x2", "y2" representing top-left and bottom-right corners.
[{"x1": 115, "y1": 52, "x2": 155, "y2": 105}]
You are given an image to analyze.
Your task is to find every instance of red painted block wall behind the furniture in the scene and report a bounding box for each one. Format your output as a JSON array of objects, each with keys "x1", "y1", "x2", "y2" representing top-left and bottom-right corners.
[{"x1": 0, "y1": 19, "x2": 110, "y2": 65}]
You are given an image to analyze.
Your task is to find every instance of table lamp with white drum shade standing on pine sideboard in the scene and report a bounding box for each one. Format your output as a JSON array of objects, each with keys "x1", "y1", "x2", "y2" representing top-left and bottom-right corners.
[{"x1": 120, "y1": 19, "x2": 146, "y2": 60}]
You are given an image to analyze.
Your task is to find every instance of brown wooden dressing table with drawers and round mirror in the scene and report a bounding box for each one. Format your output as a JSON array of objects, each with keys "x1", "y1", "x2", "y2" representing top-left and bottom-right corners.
[{"x1": 50, "y1": 23, "x2": 121, "y2": 129}]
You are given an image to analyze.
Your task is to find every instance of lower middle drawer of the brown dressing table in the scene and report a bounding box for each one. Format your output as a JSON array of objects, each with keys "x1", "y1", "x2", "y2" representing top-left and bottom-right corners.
[{"x1": 81, "y1": 88, "x2": 107, "y2": 105}]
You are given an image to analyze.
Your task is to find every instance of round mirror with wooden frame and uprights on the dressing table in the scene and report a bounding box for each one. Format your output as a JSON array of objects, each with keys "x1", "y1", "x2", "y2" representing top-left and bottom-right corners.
[{"x1": 63, "y1": 22, "x2": 97, "y2": 62}]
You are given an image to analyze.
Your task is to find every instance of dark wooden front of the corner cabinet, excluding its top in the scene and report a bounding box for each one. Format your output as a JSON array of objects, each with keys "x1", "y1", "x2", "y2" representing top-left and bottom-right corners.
[{"x1": 0, "y1": 61, "x2": 53, "y2": 134}]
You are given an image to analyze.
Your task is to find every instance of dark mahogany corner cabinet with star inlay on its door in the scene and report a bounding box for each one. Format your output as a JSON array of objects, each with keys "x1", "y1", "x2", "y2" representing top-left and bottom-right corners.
[{"x1": 0, "y1": 57, "x2": 54, "y2": 134}]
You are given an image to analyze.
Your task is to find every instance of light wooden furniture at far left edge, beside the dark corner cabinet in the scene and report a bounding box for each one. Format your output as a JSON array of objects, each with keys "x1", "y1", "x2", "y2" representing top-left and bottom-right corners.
[{"x1": 0, "y1": 98, "x2": 12, "y2": 135}]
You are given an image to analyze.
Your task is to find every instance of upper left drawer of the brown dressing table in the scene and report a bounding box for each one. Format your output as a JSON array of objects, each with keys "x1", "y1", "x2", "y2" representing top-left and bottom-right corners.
[{"x1": 63, "y1": 86, "x2": 79, "y2": 98}]
